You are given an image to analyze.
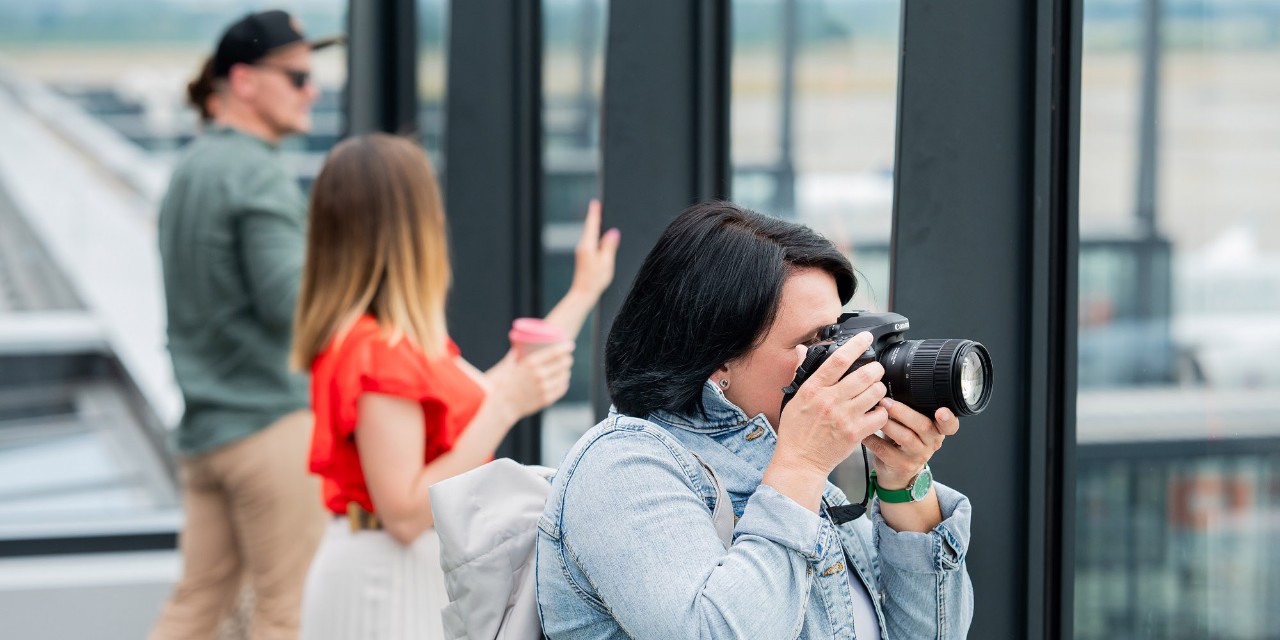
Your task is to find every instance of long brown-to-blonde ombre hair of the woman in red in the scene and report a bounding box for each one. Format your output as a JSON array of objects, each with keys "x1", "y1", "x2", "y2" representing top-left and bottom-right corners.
[{"x1": 289, "y1": 133, "x2": 452, "y2": 369}]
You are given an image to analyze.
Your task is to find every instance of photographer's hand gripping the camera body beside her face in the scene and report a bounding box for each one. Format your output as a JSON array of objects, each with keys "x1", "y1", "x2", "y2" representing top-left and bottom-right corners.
[{"x1": 774, "y1": 332, "x2": 888, "y2": 479}]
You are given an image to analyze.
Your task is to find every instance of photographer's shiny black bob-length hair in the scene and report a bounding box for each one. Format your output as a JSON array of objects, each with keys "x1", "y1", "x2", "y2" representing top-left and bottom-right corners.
[{"x1": 604, "y1": 201, "x2": 856, "y2": 417}]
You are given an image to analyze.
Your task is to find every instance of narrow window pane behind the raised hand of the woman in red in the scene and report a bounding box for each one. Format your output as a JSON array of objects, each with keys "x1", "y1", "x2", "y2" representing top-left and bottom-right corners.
[{"x1": 541, "y1": 0, "x2": 608, "y2": 465}]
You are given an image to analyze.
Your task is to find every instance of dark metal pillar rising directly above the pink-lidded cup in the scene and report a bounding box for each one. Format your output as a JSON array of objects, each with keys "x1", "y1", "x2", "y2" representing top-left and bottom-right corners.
[{"x1": 444, "y1": 0, "x2": 543, "y2": 462}]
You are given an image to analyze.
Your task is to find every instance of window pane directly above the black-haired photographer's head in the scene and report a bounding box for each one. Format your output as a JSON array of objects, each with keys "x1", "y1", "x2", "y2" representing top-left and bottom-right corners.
[{"x1": 731, "y1": 0, "x2": 901, "y2": 310}]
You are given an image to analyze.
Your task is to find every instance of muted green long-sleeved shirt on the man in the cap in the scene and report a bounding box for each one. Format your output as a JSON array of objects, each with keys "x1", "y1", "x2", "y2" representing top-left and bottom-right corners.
[{"x1": 159, "y1": 129, "x2": 308, "y2": 454}]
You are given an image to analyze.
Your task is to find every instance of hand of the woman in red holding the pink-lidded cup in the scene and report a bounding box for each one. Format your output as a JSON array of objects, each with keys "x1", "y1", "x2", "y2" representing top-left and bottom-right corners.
[{"x1": 488, "y1": 342, "x2": 573, "y2": 424}]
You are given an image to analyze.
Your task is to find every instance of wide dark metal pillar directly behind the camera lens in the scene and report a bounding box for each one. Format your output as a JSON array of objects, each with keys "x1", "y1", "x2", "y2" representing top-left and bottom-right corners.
[{"x1": 891, "y1": 0, "x2": 1080, "y2": 637}]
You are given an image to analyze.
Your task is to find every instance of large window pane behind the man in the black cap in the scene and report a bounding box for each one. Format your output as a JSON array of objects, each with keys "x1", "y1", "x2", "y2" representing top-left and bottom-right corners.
[{"x1": 0, "y1": 0, "x2": 347, "y2": 539}]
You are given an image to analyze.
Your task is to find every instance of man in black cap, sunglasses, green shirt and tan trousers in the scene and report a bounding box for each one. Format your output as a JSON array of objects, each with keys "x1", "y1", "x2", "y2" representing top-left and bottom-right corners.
[{"x1": 151, "y1": 12, "x2": 339, "y2": 639}]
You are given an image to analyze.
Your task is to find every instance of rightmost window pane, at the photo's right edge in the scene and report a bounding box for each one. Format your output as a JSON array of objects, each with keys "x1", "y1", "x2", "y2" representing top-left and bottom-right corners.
[{"x1": 1074, "y1": 0, "x2": 1280, "y2": 639}]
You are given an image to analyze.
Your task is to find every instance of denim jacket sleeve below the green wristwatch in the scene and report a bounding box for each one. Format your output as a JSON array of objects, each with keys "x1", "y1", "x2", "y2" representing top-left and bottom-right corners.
[{"x1": 870, "y1": 483, "x2": 973, "y2": 639}]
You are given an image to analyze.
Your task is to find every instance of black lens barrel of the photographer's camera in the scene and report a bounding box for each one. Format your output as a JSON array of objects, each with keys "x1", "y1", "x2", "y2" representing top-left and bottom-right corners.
[{"x1": 877, "y1": 339, "x2": 992, "y2": 416}]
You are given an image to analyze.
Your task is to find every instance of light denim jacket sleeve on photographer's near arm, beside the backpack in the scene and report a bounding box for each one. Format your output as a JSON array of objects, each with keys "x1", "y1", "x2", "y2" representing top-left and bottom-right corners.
[{"x1": 559, "y1": 430, "x2": 837, "y2": 639}]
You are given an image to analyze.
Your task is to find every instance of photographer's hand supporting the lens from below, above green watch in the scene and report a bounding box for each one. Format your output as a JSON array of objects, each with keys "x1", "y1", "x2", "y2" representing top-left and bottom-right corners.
[{"x1": 863, "y1": 398, "x2": 960, "y2": 489}]
